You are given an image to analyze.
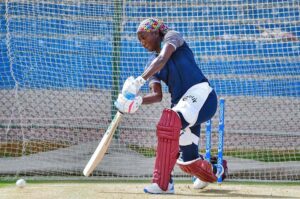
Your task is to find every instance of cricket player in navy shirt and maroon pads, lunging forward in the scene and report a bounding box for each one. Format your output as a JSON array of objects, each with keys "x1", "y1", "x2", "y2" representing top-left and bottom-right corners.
[{"x1": 115, "y1": 18, "x2": 227, "y2": 194}]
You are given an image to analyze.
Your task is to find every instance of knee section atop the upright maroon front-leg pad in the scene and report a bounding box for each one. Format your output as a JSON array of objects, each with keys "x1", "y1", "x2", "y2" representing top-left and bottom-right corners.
[{"x1": 156, "y1": 109, "x2": 181, "y2": 140}]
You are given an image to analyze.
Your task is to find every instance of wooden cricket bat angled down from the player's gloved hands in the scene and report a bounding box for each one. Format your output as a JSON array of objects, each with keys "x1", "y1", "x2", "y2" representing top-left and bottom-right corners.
[{"x1": 83, "y1": 111, "x2": 123, "y2": 177}]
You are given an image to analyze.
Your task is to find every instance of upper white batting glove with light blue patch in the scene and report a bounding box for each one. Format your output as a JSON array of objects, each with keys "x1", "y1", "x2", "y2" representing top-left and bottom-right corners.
[{"x1": 122, "y1": 76, "x2": 146, "y2": 100}]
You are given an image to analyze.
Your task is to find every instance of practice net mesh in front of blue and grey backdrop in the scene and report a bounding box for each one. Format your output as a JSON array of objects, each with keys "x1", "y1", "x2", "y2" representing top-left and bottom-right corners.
[{"x1": 0, "y1": 0, "x2": 300, "y2": 181}]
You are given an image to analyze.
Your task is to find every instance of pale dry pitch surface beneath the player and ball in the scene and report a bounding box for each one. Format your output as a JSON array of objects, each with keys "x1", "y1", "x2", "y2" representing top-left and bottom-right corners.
[{"x1": 0, "y1": 181, "x2": 300, "y2": 199}]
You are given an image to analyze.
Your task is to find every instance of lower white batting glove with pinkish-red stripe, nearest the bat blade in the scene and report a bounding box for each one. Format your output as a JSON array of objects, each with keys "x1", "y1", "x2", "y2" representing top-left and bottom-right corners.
[{"x1": 114, "y1": 94, "x2": 143, "y2": 113}]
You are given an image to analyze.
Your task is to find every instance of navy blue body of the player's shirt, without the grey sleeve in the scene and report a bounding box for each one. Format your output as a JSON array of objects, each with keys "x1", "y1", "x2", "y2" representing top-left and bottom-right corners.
[{"x1": 149, "y1": 31, "x2": 208, "y2": 104}]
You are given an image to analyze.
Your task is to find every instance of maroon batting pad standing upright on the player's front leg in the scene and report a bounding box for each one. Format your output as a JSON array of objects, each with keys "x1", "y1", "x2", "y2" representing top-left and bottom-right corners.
[{"x1": 152, "y1": 109, "x2": 181, "y2": 191}]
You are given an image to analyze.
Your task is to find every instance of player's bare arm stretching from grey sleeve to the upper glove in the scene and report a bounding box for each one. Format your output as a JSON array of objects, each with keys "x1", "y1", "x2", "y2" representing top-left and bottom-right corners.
[{"x1": 142, "y1": 43, "x2": 176, "y2": 80}]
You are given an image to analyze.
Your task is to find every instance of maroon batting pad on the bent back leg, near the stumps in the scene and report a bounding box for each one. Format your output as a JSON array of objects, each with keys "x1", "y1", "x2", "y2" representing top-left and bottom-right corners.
[{"x1": 177, "y1": 159, "x2": 217, "y2": 183}]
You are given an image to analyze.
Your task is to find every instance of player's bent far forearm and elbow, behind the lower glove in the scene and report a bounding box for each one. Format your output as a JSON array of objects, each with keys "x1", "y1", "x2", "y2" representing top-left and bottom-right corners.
[{"x1": 142, "y1": 82, "x2": 163, "y2": 104}]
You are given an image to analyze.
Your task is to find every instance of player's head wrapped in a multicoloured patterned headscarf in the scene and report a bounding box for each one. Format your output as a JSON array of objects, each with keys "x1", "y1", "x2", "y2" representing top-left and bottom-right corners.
[{"x1": 137, "y1": 18, "x2": 169, "y2": 51}]
